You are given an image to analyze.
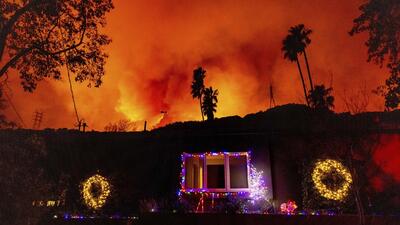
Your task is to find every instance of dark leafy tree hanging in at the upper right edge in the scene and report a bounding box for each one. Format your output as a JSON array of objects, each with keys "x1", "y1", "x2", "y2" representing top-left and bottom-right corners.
[{"x1": 350, "y1": 0, "x2": 400, "y2": 109}]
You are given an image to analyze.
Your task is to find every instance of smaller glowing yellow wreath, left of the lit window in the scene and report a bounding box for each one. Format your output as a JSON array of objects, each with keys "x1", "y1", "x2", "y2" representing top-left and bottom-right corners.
[{"x1": 81, "y1": 174, "x2": 111, "y2": 209}]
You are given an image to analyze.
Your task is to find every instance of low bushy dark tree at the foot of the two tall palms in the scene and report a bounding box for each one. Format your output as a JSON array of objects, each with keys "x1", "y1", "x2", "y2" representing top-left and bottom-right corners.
[{"x1": 308, "y1": 84, "x2": 335, "y2": 110}]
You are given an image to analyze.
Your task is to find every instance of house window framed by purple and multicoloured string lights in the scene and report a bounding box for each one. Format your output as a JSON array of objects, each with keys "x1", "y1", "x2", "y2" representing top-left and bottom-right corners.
[{"x1": 182, "y1": 152, "x2": 249, "y2": 192}]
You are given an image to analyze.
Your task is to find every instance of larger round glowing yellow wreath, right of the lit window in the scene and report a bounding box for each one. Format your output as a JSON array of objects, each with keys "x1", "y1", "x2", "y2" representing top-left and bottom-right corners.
[{"x1": 312, "y1": 159, "x2": 353, "y2": 201}]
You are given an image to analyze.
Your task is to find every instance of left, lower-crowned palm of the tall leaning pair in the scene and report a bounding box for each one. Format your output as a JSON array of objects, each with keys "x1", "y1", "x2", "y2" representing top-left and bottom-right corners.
[{"x1": 282, "y1": 34, "x2": 310, "y2": 106}]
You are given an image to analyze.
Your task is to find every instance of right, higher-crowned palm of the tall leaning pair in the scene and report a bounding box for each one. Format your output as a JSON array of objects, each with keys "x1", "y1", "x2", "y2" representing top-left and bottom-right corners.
[{"x1": 289, "y1": 24, "x2": 314, "y2": 91}]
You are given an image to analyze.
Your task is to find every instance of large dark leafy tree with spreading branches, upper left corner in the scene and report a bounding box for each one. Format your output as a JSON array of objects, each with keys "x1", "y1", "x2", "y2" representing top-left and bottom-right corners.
[{"x1": 0, "y1": 0, "x2": 113, "y2": 91}]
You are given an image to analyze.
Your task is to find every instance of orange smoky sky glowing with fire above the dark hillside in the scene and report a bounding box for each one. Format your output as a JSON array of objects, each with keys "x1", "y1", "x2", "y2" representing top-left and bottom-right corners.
[{"x1": 3, "y1": 0, "x2": 388, "y2": 130}]
